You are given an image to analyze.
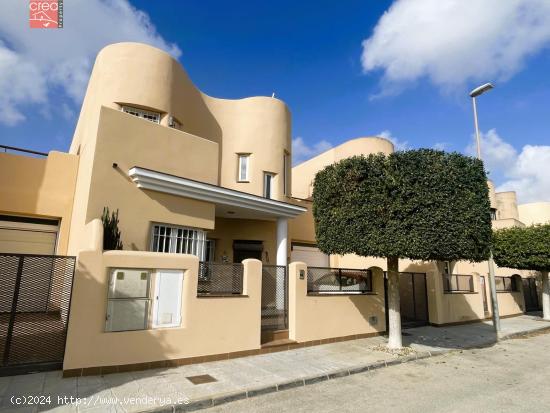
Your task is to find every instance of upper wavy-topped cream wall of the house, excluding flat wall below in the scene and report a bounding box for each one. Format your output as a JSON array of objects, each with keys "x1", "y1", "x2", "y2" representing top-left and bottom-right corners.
[{"x1": 71, "y1": 43, "x2": 291, "y2": 200}]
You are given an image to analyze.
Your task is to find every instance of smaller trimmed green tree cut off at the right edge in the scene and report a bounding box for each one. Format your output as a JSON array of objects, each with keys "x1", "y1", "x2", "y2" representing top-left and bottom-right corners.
[{"x1": 493, "y1": 223, "x2": 550, "y2": 320}]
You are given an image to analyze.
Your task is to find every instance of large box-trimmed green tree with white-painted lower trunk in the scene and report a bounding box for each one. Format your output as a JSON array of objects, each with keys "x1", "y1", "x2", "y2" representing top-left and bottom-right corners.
[{"x1": 313, "y1": 149, "x2": 492, "y2": 348}]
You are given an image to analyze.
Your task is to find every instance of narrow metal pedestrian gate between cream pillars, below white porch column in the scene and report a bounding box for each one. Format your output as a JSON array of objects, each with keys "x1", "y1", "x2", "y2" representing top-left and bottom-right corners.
[{"x1": 262, "y1": 265, "x2": 288, "y2": 330}]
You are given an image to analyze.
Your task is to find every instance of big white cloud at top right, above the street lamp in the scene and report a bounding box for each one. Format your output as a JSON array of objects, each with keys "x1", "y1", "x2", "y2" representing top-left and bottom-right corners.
[{"x1": 361, "y1": 0, "x2": 550, "y2": 95}]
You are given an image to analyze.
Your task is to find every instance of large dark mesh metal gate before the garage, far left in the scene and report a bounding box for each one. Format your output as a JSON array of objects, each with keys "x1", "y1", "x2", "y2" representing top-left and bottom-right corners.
[{"x1": 0, "y1": 254, "x2": 75, "y2": 375}]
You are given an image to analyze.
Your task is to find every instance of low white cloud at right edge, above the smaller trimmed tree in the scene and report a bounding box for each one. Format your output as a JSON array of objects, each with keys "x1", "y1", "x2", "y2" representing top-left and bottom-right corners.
[{"x1": 466, "y1": 129, "x2": 550, "y2": 203}]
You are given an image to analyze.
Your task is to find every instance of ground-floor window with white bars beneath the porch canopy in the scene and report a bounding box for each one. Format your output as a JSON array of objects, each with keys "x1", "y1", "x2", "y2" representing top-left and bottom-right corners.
[{"x1": 150, "y1": 223, "x2": 206, "y2": 261}]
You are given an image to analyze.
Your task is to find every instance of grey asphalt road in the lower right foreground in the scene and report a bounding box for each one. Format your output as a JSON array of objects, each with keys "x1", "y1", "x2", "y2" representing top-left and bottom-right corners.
[{"x1": 204, "y1": 328, "x2": 550, "y2": 413}]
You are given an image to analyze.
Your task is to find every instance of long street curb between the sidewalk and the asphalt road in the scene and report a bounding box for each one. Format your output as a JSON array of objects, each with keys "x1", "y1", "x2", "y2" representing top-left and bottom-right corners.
[{"x1": 142, "y1": 326, "x2": 550, "y2": 413}]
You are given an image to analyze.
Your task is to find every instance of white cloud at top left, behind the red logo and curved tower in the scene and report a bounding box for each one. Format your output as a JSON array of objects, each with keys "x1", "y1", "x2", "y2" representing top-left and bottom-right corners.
[{"x1": 0, "y1": 0, "x2": 181, "y2": 125}]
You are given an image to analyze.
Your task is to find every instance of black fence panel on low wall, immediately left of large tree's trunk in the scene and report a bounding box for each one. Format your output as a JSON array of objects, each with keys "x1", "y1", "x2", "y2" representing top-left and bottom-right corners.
[{"x1": 307, "y1": 267, "x2": 372, "y2": 294}]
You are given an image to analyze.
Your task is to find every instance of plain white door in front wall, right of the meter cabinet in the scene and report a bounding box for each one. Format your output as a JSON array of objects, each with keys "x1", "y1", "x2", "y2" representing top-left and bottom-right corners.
[{"x1": 153, "y1": 270, "x2": 183, "y2": 327}]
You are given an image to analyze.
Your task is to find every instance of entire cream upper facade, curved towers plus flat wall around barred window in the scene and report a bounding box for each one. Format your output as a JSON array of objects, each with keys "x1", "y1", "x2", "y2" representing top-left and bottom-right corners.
[{"x1": 68, "y1": 43, "x2": 291, "y2": 253}]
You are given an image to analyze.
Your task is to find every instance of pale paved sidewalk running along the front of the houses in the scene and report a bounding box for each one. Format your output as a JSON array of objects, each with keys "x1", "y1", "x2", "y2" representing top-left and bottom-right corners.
[{"x1": 0, "y1": 315, "x2": 550, "y2": 413}]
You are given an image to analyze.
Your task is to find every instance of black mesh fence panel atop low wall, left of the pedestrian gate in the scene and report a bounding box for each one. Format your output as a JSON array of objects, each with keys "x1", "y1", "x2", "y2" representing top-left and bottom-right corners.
[{"x1": 197, "y1": 261, "x2": 243, "y2": 296}]
